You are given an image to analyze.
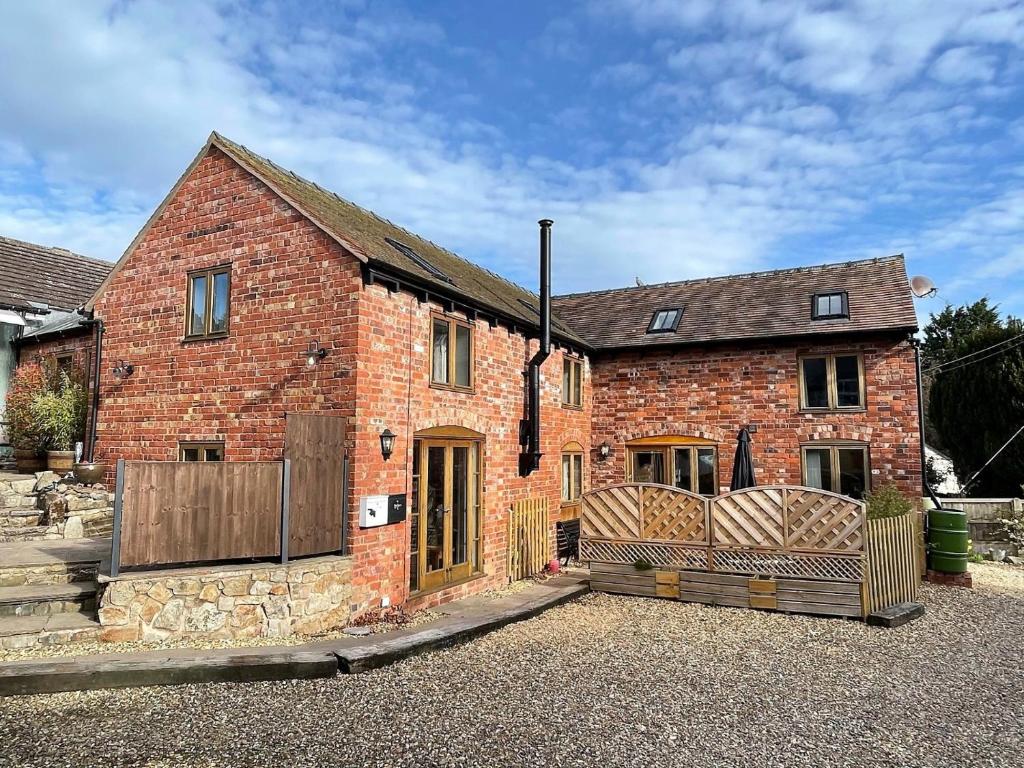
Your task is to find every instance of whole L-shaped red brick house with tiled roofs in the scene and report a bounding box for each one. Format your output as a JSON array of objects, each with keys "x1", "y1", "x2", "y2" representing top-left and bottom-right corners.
[{"x1": 37, "y1": 134, "x2": 920, "y2": 610}]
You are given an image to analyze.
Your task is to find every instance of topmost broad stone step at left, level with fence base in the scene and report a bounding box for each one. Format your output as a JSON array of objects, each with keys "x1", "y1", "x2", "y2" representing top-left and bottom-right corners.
[{"x1": 0, "y1": 539, "x2": 111, "y2": 587}]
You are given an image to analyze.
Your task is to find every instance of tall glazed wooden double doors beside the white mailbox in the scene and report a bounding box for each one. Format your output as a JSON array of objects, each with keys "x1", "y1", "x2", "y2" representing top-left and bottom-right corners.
[{"x1": 416, "y1": 440, "x2": 478, "y2": 590}]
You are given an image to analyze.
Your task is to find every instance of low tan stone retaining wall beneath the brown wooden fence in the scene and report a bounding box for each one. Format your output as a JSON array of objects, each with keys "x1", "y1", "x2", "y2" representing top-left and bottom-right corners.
[{"x1": 99, "y1": 556, "x2": 352, "y2": 642}]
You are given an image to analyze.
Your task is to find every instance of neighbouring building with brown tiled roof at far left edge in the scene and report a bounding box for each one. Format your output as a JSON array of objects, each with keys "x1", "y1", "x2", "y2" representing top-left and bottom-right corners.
[{"x1": 0, "y1": 237, "x2": 114, "y2": 460}]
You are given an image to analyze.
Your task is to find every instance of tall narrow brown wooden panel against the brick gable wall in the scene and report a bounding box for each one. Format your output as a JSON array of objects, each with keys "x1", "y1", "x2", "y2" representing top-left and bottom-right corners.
[{"x1": 285, "y1": 414, "x2": 348, "y2": 557}]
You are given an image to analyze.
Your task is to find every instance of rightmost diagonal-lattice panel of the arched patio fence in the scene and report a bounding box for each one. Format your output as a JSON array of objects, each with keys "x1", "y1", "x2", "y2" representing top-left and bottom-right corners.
[{"x1": 785, "y1": 487, "x2": 864, "y2": 552}]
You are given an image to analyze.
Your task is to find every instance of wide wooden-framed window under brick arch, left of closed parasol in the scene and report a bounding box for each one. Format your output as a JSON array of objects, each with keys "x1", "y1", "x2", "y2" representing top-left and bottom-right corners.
[{"x1": 626, "y1": 437, "x2": 718, "y2": 496}]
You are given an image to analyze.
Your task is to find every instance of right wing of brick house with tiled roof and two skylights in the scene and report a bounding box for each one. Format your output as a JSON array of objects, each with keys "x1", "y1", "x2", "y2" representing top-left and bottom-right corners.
[{"x1": 554, "y1": 256, "x2": 922, "y2": 498}]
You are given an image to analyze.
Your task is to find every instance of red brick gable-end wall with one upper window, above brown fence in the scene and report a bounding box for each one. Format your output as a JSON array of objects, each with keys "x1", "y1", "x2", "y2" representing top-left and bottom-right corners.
[{"x1": 96, "y1": 148, "x2": 360, "y2": 463}]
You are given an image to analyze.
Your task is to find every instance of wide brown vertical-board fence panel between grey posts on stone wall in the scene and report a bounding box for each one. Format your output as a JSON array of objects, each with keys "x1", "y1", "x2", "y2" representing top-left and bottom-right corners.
[{"x1": 119, "y1": 462, "x2": 283, "y2": 566}]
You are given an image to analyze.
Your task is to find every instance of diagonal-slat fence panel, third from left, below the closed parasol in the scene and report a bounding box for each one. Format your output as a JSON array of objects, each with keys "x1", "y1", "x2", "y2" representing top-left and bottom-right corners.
[{"x1": 711, "y1": 487, "x2": 785, "y2": 548}]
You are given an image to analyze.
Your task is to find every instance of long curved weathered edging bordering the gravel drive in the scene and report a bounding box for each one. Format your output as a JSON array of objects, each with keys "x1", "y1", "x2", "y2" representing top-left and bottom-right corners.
[{"x1": 0, "y1": 577, "x2": 590, "y2": 696}]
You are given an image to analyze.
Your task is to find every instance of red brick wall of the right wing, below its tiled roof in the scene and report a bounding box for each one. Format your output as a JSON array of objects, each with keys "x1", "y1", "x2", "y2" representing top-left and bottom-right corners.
[{"x1": 592, "y1": 338, "x2": 921, "y2": 497}]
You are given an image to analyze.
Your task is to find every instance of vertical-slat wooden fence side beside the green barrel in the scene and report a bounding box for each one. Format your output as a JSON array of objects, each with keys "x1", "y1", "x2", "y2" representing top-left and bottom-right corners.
[{"x1": 866, "y1": 513, "x2": 921, "y2": 613}]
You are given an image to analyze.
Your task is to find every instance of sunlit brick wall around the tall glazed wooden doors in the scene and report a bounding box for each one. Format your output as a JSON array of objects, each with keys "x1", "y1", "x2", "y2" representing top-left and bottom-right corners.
[{"x1": 350, "y1": 286, "x2": 592, "y2": 607}]
